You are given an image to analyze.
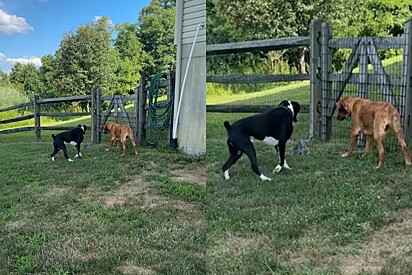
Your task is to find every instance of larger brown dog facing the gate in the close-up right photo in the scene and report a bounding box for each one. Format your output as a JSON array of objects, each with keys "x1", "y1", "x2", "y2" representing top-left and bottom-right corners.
[{"x1": 336, "y1": 97, "x2": 411, "y2": 168}]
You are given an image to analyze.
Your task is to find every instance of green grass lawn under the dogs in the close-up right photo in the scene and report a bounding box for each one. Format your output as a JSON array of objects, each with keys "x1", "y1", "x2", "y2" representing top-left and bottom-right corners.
[{"x1": 206, "y1": 114, "x2": 412, "y2": 274}]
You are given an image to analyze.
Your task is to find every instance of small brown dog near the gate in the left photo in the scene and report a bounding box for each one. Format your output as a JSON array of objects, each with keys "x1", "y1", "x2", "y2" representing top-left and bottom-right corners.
[{"x1": 103, "y1": 123, "x2": 138, "y2": 156}]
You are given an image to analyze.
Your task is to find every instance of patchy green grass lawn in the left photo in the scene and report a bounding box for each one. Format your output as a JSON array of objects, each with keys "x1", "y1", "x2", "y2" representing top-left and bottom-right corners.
[{"x1": 0, "y1": 118, "x2": 206, "y2": 274}]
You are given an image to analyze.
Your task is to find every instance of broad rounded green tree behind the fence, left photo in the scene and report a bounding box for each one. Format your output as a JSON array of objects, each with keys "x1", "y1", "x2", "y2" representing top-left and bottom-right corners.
[{"x1": 55, "y1": 17, "x2": 116, "y2": 96}]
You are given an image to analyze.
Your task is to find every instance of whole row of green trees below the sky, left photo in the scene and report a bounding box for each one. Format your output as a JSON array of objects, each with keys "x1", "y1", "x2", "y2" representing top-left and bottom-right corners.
[{"x1": 0, "y1": 0, "x2": 175, "y2": 98}]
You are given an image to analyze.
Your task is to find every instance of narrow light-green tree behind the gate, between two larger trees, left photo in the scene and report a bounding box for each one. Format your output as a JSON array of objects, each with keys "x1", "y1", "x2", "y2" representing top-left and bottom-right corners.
[{"x1": 114, "y1": 23, "x2": 147, "y2": 94}]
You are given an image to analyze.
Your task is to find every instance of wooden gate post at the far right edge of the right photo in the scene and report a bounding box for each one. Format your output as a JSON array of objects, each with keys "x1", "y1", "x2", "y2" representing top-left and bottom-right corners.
[{"x1": 400, "y1": 19, "x2": 412, "y2": 141}]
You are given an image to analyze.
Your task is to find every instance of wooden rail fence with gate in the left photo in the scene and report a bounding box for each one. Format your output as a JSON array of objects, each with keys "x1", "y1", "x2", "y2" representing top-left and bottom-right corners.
[{"x1": 0, "y1": 72, "x2": 174, "y2": 147}]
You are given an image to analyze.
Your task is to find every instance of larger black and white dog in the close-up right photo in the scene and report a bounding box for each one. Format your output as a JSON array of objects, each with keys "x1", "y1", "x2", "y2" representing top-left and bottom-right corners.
[{"x1": 222, "y1": 100, "x2": 300, "y2": 180}]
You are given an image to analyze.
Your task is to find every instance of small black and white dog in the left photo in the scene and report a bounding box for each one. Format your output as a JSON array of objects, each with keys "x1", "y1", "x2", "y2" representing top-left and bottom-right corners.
[{"x1": 51, "y1": 124, "x2": 87, "y2": 161}]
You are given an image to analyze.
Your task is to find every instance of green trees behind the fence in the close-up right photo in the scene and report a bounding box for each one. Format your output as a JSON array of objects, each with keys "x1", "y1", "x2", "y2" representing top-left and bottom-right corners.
[{"x1": 206, "y1": 0, "x2": 412, "y2": 77}]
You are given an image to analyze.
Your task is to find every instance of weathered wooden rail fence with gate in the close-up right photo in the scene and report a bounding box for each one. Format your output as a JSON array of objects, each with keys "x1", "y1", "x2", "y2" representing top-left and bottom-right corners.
[{"x1": 206, "y1": 20, "x2": 412, "y2": 144}]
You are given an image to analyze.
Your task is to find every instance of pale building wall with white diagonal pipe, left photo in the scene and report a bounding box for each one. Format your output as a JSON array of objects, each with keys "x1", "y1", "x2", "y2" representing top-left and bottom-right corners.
[{"x1": 173, "y1": 0, "x2": 206, "y2": 155}]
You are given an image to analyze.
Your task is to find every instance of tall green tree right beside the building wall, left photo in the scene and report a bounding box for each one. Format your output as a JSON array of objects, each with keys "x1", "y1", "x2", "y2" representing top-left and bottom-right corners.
[{"x1": 138, "y1": 0, "x2": 176, "y2": 77}]
